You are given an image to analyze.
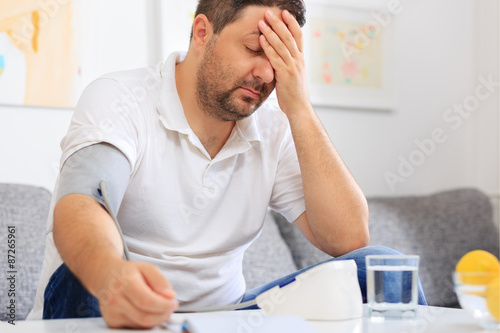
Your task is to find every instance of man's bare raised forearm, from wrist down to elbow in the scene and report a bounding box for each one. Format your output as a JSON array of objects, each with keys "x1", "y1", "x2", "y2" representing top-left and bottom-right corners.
[{"x1": 289, "y1": 105, "x2": 369, "y2": 255}]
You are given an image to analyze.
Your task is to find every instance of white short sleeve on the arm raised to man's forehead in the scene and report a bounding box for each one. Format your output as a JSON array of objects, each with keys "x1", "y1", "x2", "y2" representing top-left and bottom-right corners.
[{"x1": 269, "y1": 129, "x2": 306, "y2": 222}]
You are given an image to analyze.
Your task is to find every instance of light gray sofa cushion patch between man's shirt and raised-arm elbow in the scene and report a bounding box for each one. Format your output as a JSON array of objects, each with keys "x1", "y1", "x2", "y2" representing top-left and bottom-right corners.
[{"x1": 243, "y1": 212, "x2": 297, "y2": 290}]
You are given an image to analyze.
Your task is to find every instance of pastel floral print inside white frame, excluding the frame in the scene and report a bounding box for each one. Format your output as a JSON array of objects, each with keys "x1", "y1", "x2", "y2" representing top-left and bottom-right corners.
[{"x1": 310, "y1": 18, "x2": 382, "y2": 88}]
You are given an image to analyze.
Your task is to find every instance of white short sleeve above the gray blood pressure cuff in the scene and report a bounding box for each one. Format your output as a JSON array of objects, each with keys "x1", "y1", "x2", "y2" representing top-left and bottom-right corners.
[{"x1": 61, "y1": 78, "x2": 143, "y2": 169}]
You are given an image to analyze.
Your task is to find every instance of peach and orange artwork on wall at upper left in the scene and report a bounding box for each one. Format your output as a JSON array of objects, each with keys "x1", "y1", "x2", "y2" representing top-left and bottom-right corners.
[{"x1": 0, "y1": 0, "x2": 76, "y2": 107}]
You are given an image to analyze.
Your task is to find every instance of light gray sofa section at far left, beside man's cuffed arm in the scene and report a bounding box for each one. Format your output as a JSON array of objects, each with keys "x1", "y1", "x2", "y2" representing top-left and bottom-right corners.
[{"x1": 0, "y1": 184, "x2": 51, "y2": 321}]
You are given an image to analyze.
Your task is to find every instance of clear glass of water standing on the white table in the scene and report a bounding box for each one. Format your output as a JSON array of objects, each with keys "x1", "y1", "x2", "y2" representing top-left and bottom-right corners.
[{"x1": 366, "y1": 255, "x2": 419, "y2": 319}]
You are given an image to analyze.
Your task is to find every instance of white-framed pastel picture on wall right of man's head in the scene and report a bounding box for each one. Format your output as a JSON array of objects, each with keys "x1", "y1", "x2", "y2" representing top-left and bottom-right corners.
[{"x1": 304, "y1": 0, "x2": 397, "y2": 109}]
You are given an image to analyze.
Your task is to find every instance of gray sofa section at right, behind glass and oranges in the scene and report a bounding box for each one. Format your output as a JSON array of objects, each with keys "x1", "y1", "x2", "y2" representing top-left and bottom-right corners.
[{"x1": 368, "y1": 189, "x2": 499, "y2": 307}]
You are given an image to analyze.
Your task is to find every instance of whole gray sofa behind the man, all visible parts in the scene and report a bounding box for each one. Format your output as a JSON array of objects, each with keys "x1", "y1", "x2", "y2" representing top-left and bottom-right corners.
[{"x1": 0, "y1": 184, "x2": 499, "y2": 321}]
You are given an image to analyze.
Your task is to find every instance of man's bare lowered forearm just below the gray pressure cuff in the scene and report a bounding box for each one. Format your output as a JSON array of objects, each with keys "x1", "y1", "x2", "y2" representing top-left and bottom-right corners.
[{"x1": 53, "y1": 194, "x2": 123, "y2": 295}]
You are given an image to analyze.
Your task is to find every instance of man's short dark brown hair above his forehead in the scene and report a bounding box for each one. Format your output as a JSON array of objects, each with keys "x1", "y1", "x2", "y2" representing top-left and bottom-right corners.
[{"x1": 191, "y1": 0, "x2": 306, "y2": 38}]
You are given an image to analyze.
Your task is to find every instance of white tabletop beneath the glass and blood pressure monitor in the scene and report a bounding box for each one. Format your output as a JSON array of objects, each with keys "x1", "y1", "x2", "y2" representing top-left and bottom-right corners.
[{"x1": 0, "y1": 305, "x2": 485, "y2": 333}]
